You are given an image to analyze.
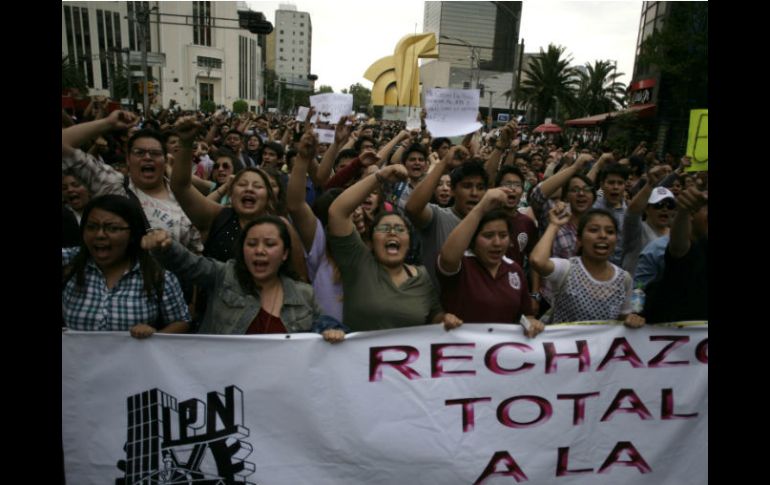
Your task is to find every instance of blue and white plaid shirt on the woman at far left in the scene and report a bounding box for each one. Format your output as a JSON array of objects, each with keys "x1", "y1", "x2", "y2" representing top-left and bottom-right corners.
[{"x1": 62, "y1": 248, "x2": 190, "y2": 331}]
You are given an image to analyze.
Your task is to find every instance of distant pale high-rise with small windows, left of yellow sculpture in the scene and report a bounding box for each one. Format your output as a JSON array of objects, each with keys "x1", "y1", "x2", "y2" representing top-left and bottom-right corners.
[{"x1": 273, "y1": 4, "x2": 313, "y2": 91}]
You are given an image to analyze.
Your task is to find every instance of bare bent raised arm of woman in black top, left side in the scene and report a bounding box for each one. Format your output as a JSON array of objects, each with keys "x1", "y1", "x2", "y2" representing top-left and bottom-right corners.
[{"x1": 171, "y1": 116, "x2": 222, "y2": 232}]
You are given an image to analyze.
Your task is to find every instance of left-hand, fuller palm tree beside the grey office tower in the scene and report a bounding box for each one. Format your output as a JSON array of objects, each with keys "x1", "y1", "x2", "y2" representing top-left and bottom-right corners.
[{"x1": 521, "y1": 44, "x2": 578, "y2": 123}]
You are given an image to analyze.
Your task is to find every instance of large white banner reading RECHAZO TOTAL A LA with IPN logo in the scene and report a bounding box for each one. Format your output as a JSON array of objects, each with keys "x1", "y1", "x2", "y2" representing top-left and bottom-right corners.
[{"x1": 62, "y1": 324, "x2": 708, "y2": 485}]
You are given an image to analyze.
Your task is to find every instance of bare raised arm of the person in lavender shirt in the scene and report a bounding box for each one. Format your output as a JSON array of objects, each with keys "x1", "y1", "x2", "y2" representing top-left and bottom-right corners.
[{"x1": 286, "y1": 131, "x2": 318, "y2": 251}]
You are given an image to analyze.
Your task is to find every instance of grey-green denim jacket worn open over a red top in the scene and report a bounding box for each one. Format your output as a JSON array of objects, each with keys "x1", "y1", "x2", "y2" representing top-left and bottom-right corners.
[{"x1": 152, "y1": 241, "x2": 328, "y2": 335}]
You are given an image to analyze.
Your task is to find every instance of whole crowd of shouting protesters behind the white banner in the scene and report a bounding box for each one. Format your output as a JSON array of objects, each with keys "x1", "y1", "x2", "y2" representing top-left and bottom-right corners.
[{"x1": 62, "y1": 99, "x2": 708, "y2": 342}]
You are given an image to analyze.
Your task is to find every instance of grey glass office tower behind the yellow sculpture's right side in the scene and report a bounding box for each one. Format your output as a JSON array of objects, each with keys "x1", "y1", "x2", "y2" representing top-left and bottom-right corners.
[{"x1": 420, "y1": 2, "x2": 521, "y2": 119}]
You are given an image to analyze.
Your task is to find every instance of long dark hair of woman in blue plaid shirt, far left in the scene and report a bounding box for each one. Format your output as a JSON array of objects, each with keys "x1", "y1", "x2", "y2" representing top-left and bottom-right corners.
[{"x1": 65, "y1": 194, "x2": 164, "y2": 300}]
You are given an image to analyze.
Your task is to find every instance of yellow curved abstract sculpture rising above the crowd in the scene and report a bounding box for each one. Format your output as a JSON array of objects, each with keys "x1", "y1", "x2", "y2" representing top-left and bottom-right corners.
[{"x1": 364, "y1": 32, "x2": 438, "y2": 106}]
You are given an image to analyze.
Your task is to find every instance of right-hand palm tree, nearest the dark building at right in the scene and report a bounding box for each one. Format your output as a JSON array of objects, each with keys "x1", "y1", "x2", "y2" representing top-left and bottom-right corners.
[{"x1": 572, "y1": 61, "x2": 626, "y2": 117}]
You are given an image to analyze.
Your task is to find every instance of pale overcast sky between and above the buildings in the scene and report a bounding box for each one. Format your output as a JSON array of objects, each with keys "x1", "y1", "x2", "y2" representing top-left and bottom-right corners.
[{"x1": 247, "y1": 0, "x2": 642, "y2": 93}]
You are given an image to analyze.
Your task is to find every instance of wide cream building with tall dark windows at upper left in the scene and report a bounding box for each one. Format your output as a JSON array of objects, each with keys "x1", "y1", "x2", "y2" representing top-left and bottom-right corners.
[{"x1": 62, "y1": 1, "x2": 264, "y2": 111}]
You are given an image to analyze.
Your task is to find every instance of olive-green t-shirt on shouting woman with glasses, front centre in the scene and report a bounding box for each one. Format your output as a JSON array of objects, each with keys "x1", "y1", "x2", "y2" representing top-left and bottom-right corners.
[{"x1": 328, "y1": 231, "x2": 442, "y2": 332}]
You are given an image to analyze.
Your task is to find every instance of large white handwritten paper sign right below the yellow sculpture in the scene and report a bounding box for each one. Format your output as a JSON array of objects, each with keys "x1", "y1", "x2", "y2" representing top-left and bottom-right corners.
[{"x1": 425, "y1": 88, "x2": 481, "y2": 138}]
